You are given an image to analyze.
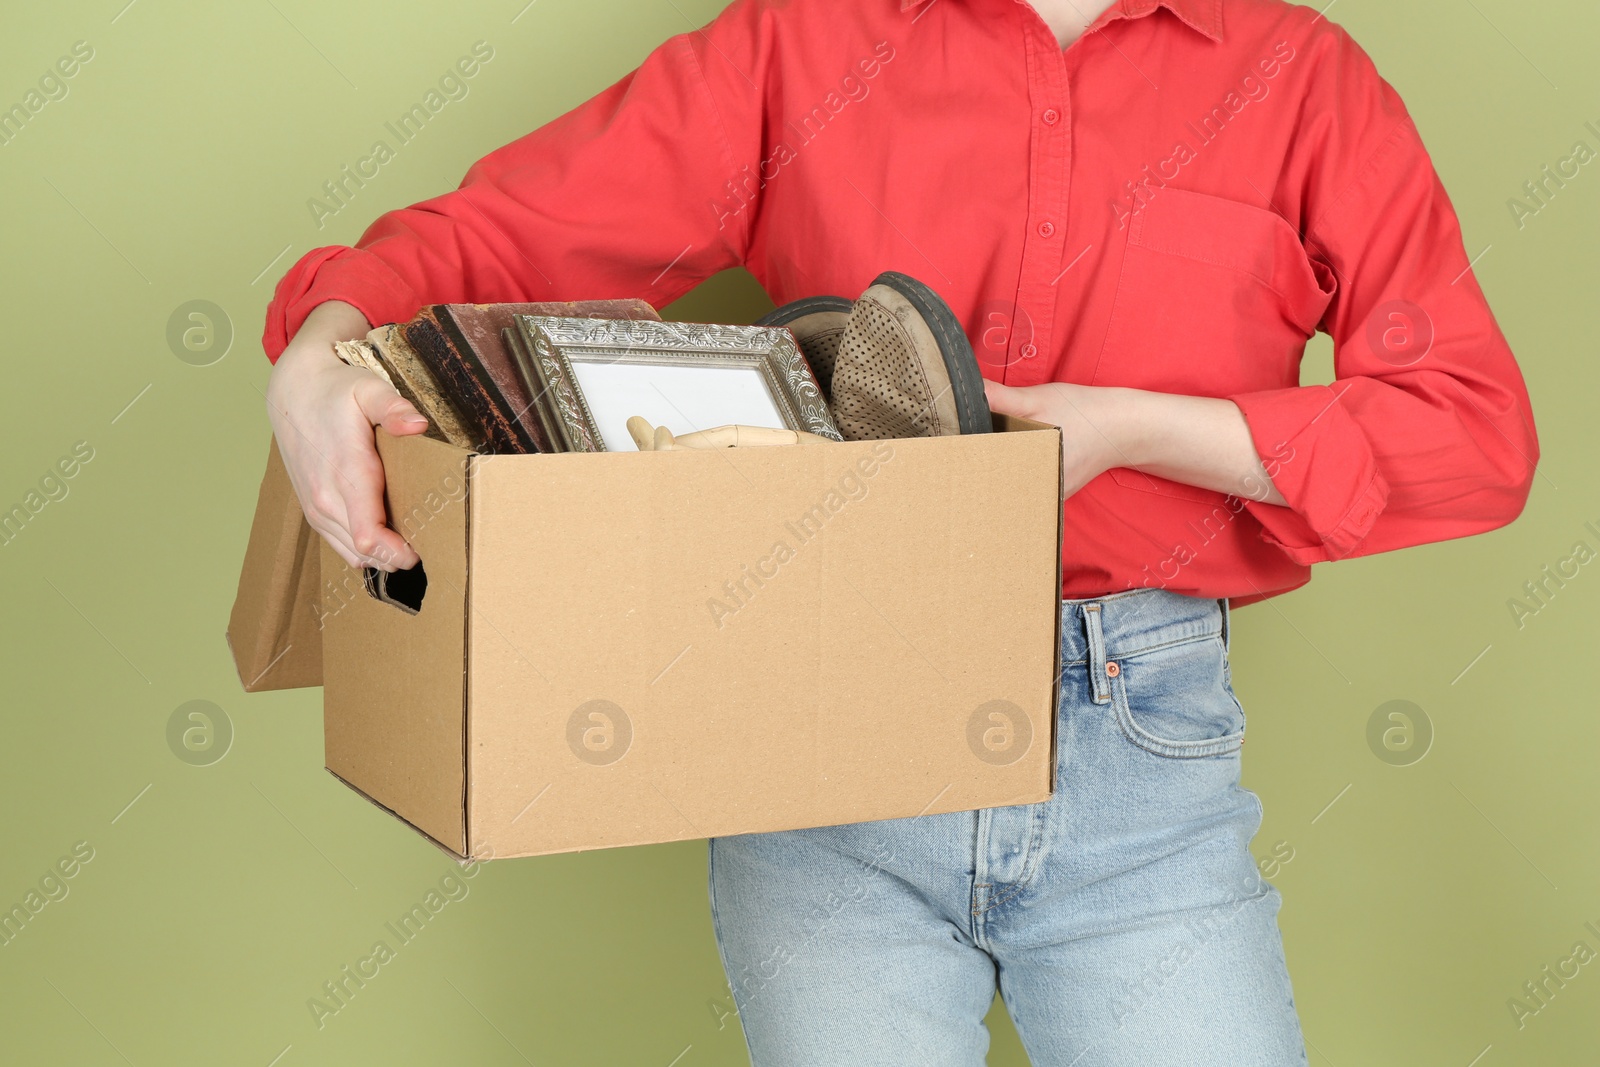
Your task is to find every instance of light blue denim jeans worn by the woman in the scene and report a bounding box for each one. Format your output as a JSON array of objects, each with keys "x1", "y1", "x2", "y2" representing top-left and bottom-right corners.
[{"x1": 710, "y1": 590, "x2": 1306, "y2": 1067}]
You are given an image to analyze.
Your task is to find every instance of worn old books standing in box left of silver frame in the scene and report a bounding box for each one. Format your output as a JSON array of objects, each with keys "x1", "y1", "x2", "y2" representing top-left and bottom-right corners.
[{"x1": 334, "y1": 299, "x2": 661, "y2": 453}]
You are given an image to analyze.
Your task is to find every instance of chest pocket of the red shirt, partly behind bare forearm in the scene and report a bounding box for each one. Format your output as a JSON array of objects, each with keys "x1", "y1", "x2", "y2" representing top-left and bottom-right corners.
[{"x1": 1090, "y1": 187, "x2": 1336, "y2": 501}]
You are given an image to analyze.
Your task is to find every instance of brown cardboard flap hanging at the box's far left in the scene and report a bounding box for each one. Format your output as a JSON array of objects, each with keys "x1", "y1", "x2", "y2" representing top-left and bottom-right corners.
[{"x1": 227, "y1": 438, "x2": 322, "y2": 693}]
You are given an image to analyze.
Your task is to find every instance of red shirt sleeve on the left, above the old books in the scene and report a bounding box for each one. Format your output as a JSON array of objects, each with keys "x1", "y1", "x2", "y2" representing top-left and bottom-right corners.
[{"x1": 262, "y1": 3, "x2": 762, "y2": 362}]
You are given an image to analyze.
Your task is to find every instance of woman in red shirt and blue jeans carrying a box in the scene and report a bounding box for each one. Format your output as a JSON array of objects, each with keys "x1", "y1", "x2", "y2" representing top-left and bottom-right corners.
[{"x1": 264, "y1": 0, "x2": 1538, "y2": 1067}]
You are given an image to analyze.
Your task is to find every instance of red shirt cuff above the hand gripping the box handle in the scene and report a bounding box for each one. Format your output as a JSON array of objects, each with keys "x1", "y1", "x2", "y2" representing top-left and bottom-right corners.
[{"x1": 261, "y1": 245, "x2": 422, "y2": 363}]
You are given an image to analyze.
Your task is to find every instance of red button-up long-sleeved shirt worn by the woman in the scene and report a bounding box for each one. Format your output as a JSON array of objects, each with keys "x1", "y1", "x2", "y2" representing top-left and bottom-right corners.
[{"x1": 264, "y1": 0, "x2": 1538, "y2": 601}]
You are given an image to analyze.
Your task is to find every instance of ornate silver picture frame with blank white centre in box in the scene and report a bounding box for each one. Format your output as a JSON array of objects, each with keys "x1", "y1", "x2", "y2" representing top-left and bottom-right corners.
[{"x1": 507, "y1": 315, "x2": 840, "y2": 453}]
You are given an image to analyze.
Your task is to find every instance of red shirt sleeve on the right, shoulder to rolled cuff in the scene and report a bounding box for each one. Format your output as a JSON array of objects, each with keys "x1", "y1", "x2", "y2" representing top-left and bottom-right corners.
[{"x1": 1230, "y1": 31, "x2": 1539, "y2": 565}]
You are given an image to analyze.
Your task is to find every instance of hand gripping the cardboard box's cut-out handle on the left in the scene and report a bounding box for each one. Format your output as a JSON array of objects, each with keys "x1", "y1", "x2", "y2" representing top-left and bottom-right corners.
[{"x1": 267, "y1": 301, "x2": 427, "y2": 571}]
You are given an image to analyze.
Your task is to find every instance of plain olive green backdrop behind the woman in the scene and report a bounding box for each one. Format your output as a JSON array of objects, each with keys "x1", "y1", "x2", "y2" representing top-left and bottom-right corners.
[{"x1": 0, "y1": 0, "x2": 1600, "y2": 1067}]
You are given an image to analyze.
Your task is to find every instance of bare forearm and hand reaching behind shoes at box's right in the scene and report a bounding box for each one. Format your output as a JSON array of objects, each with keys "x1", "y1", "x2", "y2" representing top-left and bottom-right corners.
[{"x1": 984, "y1": 381, "x2": 1285, "y2": 506}]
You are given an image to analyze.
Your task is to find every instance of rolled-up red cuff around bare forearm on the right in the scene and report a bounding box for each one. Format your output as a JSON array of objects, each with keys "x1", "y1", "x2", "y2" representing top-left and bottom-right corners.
[{"x1": 1229, "y1": 386, "x2": 1389, "y2": 566}]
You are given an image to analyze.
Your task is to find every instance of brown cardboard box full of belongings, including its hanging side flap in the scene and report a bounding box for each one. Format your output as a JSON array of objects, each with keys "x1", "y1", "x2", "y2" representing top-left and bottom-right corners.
[{"x1": 229, "y1": 416, "x2": 1061, "y2": 857}]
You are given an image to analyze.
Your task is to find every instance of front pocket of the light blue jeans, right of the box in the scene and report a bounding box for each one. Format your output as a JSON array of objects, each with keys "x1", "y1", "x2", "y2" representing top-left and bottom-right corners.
[{"x1": 1107, "y1": 633, "x2": 1245, "y2": 760}]
